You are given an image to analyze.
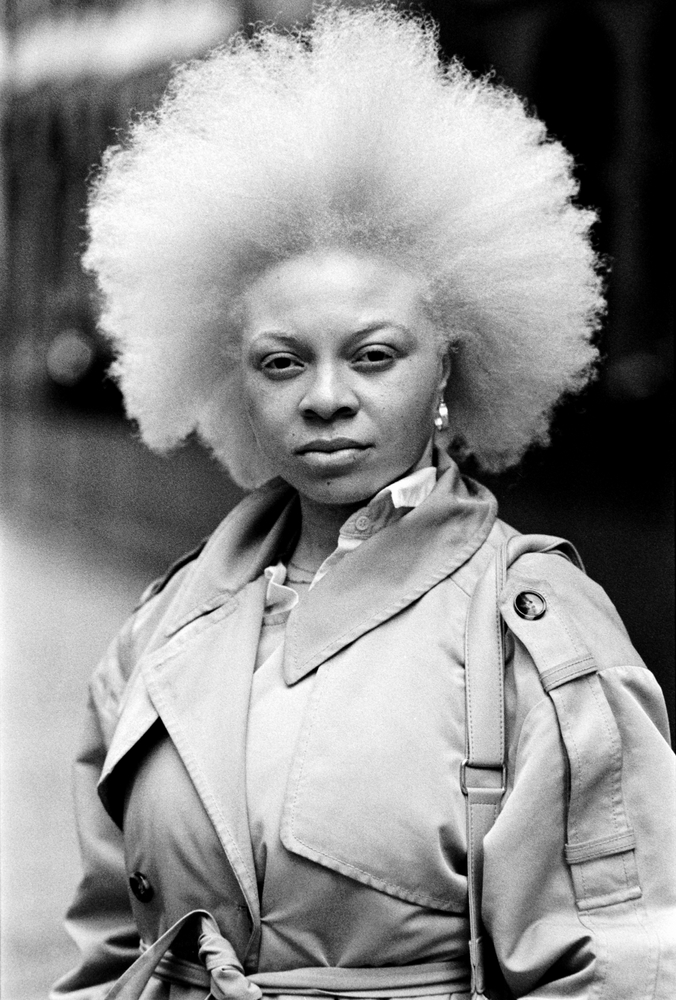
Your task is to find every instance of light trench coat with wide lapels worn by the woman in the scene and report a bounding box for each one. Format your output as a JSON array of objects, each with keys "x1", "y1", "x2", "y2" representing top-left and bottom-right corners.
[{"x1": 52, "y1": 461, "x2": 676, "y2": 1000}]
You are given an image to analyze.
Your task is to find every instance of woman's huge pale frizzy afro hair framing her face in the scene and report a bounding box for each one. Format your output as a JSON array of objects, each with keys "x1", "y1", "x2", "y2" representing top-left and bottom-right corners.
[{"x1": 84, "y1": 6, "x2": 603, "y2": 487}]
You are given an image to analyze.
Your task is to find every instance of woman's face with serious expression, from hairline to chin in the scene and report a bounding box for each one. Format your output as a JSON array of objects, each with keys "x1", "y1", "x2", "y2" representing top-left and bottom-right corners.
[{"x1": 242, "y1": 253, "x2": 448, "y2": 505}]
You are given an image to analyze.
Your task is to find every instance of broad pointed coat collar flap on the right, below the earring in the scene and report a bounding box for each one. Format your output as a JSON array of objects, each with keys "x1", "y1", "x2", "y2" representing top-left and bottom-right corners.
[{"x1": 284, "y1": 463, "x2": 497, "y2": 684}]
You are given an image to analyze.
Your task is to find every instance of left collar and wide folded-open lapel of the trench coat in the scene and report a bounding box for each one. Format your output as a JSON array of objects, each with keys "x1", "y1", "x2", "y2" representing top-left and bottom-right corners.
[{"x1": 99, "y1": 480, "x2": 296, "y2": 926}]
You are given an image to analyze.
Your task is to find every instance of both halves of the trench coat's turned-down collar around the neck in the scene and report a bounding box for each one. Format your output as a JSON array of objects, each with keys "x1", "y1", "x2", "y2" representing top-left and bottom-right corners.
[{"x1": 153, "y1": 453, "x2": 497, "y2": 656}]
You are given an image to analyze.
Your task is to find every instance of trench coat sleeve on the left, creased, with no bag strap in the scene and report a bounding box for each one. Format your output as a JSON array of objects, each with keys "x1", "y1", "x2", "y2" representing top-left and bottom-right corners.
[{"x1": 50, "y1": 626, "x2": 139, "y2": 1000}]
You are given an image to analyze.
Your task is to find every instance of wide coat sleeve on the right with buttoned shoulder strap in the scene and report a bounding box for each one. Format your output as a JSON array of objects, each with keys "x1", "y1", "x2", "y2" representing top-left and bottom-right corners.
[{"x1": 482, "y1": 555, "x2": 676, "y2": 1000}]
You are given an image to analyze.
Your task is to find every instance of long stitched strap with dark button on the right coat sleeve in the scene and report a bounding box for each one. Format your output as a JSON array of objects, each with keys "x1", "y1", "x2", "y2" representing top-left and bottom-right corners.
[{"x1": 499, "y1": 556, "x2": 641, "y2": 912}]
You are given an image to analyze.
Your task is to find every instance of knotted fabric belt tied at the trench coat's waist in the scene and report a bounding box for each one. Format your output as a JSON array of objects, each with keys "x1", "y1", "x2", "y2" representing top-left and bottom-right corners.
[{"x1": 106, "y1": 910, "x2": 469, "y2": 1000}]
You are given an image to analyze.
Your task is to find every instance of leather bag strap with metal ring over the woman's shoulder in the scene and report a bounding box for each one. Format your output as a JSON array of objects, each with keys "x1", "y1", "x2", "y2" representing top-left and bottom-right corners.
[{"x1": 460, "y1": 535, "x2": 584, "y2": 997}]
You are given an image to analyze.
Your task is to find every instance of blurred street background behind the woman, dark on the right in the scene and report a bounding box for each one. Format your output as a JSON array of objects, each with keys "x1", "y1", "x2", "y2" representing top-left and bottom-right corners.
[{"x1": 0, "y1": 0, "x2": 674, "y2": 1000}]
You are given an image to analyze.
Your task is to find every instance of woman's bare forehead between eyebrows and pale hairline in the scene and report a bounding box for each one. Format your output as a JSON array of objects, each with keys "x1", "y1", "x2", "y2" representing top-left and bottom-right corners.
[{"x1": 244, "y1": 253, "x2": 421, "y2": 333}]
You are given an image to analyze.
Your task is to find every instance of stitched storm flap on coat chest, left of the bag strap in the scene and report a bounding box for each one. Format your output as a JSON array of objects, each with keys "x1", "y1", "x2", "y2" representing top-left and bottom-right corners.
[{"x1": 281, "y1": 593, "x2": 467, "y2": 912}]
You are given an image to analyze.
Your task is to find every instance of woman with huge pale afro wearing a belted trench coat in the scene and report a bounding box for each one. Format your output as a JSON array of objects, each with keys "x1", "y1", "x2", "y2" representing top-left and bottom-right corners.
[{"x1": 53, "y1": 8, "x2": 675, "y2": 1000}]
